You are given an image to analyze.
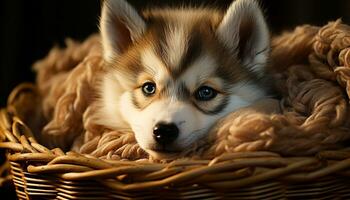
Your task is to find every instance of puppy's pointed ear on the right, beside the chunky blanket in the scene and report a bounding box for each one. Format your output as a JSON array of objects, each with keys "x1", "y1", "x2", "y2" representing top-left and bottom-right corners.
[{"x1": 217, "y1": 0, "x2": 270, "y2": 74}]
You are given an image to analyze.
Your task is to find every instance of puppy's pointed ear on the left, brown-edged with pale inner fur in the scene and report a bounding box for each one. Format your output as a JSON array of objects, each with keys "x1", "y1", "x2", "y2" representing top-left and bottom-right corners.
[{"x1": 100, "y1": 0, "x2": 146, "y2": 61}]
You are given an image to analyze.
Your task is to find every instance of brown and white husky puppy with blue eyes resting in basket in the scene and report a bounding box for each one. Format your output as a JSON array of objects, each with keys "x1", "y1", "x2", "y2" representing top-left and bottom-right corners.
[{"x1": 98, "y1": 0, "x2": 270, "y2": 158}]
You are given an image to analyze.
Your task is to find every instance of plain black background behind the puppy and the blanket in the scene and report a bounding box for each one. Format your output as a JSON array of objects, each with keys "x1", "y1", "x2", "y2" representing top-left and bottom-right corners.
[{"x1": 0, "y1": 0, "x2": 350, "y2": 198}]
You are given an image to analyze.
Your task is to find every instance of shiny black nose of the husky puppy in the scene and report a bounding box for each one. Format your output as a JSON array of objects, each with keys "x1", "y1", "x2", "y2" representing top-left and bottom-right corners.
[{"x1": 153, "y1": 123, "x2": 179, "y2": 145}]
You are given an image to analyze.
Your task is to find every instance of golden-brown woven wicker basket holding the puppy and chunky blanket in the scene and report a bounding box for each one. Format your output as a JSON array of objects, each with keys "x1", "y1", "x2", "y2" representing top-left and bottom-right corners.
[{"x1": 0, "y1": 85, "x2": 350, "y2": 200}]
